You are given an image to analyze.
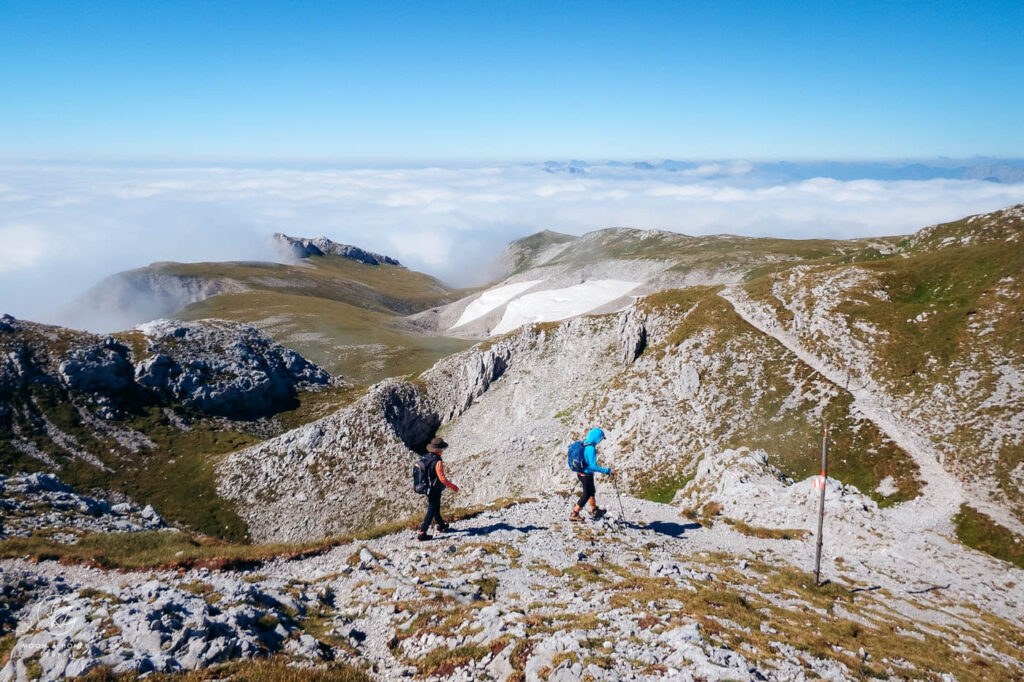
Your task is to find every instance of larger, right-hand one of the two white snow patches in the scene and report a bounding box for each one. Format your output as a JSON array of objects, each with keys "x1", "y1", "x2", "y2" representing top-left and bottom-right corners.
[{"x1": 490, "y1": 280, "x2": 640, "y2": 336}]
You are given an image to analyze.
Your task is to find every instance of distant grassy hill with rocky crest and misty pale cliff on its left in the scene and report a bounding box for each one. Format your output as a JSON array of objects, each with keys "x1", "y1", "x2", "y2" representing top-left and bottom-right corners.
[{"x1": 71, "y1": 235, "x2": 467, "y2": 384}]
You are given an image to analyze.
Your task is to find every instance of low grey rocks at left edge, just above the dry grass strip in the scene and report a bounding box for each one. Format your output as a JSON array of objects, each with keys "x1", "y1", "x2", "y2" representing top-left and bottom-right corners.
[{"x1": 0, "y1": 473, "x2": 167, "y2": 545}]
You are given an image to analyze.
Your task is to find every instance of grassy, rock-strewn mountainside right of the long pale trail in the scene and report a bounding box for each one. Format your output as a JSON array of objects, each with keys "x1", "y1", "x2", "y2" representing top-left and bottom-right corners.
[{"x1": 733, "y1": 202, "x2": 1024, "y2": 532}]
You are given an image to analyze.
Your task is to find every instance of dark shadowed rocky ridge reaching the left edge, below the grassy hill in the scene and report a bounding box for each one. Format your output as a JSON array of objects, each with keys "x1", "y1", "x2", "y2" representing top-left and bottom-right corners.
[{"x1": 0, "y1": 316, "x2": 331, "y2": 420}]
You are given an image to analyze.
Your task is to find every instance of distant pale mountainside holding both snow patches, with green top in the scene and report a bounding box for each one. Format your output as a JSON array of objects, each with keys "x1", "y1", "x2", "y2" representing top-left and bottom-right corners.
[{"x1": 419, "y1": 228, "x2": 898, "y2": 339}]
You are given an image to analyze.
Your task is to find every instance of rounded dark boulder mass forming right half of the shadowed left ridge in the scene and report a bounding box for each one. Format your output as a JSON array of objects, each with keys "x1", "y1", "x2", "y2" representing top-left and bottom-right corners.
[{"x1": 135, "y1": 319, "x2": 331, "y2": 417}]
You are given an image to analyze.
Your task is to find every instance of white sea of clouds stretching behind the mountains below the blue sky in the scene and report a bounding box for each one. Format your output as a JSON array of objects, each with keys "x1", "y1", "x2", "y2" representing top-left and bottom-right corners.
[{"x1": 0, "y1": 162, "x2": 1024, "y2": 322}]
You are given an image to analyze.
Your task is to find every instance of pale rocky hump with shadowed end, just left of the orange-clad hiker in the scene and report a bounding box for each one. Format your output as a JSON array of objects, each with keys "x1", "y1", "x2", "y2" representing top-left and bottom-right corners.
[{"x1": 217, "y1": 381, "x2": 440, "y2": 542}]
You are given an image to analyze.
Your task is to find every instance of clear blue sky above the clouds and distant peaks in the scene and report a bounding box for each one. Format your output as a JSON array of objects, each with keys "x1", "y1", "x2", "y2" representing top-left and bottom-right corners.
[{"x1": 0, "y1": 0, "x2": 1024, "y2": 157}]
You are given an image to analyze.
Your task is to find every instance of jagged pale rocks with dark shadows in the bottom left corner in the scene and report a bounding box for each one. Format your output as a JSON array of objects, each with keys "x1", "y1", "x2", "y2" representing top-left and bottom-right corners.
[{"x1": 0, "y1": 571, "x2": 329, "y2": 682}]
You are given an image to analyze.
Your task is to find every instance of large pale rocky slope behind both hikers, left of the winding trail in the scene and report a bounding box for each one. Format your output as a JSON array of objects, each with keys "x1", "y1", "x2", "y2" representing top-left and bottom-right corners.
[{"x1": 220, "y1": 278, "x2": 921, "y2": 541}]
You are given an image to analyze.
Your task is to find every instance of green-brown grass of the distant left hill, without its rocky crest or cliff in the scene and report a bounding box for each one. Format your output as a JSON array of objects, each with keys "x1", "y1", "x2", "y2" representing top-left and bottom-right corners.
[{"x1": 159, "y1": 256, "x2": 469, "y2": 384}]
